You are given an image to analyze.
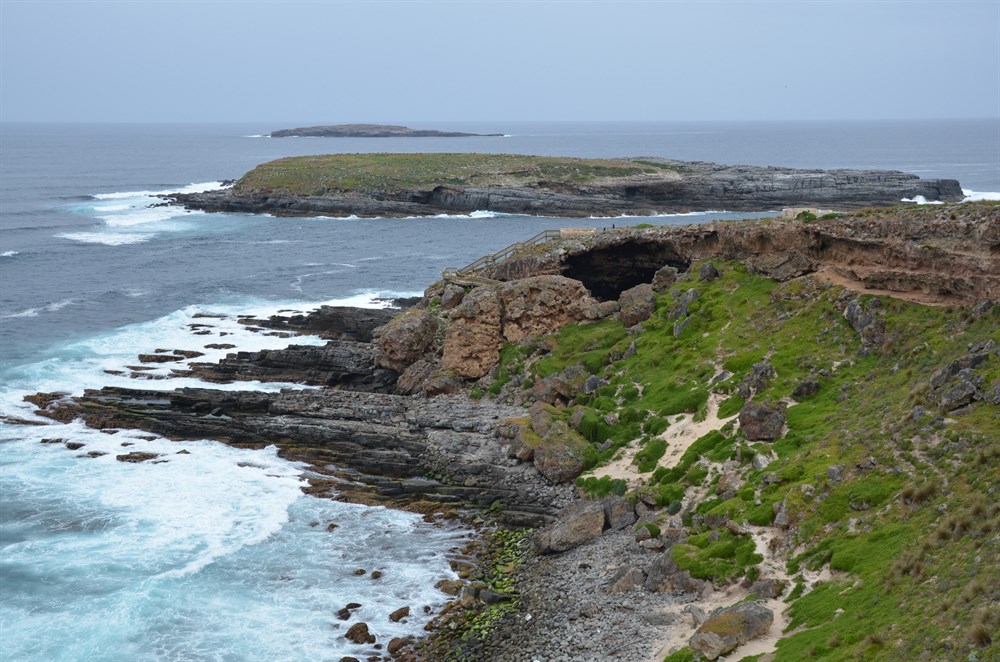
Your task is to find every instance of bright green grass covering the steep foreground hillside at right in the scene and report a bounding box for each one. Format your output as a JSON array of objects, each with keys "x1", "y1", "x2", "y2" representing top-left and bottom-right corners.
[{"x1": 480, "y1": 263, "x2": 1000, "y2": 660}]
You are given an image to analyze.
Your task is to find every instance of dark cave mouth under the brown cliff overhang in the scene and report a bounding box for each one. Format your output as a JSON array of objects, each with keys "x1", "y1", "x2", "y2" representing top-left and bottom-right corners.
[{"x1": 562, "y1": 240, "x2": 691, "y2": 301}]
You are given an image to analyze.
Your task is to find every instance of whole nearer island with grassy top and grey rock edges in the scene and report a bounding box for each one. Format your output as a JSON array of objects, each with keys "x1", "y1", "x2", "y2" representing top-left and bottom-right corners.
[{"x1": 170, "y1": 154, "x2": 962, "y2": 217}]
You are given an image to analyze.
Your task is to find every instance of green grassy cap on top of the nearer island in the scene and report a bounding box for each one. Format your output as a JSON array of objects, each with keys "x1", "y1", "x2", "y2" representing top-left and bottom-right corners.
[{"x1": 235, "y1": 154, "x2": 676, "y2": 195}]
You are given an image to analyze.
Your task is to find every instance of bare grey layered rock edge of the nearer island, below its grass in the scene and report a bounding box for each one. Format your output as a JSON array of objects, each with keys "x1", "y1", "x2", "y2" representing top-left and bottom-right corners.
[{"x1": 168, "y1": 158, "x2": 963, "y2": 218}]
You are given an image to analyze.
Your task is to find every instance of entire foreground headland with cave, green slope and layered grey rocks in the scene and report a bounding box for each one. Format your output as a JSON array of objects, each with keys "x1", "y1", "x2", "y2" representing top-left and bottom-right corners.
[{"x1": 25, "y1": 203, "x2": 1000, "y2": 662}]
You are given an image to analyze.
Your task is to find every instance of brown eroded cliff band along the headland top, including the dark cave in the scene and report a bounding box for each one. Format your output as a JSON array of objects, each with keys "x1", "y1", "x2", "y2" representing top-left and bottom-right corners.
[{"x1": 492, "y1": 205, "x2": 1000, "y2": 303}]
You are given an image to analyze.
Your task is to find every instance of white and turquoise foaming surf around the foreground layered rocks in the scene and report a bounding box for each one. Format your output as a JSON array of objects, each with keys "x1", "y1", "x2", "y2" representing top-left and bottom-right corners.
[{"x1": 0, "y1": 292, "x2": 465, "y2": 662}]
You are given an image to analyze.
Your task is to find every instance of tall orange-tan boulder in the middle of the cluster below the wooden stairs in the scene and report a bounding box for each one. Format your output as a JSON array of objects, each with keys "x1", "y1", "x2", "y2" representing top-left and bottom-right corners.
[{"x1": 441, "y1": 287, "x2": 503, "y2": 379}]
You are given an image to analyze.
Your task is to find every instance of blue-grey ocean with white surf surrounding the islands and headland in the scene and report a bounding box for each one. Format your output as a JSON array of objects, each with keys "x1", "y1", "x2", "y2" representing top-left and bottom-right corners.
[{"x1": 0, "y1": 119, "x2": 1000, "y2": 661}]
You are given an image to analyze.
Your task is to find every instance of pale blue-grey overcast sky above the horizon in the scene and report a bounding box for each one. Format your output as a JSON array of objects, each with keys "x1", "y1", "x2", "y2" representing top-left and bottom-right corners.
[{"x1": 0, "y1": 0, "x2": 1000, "y2": 123}]
